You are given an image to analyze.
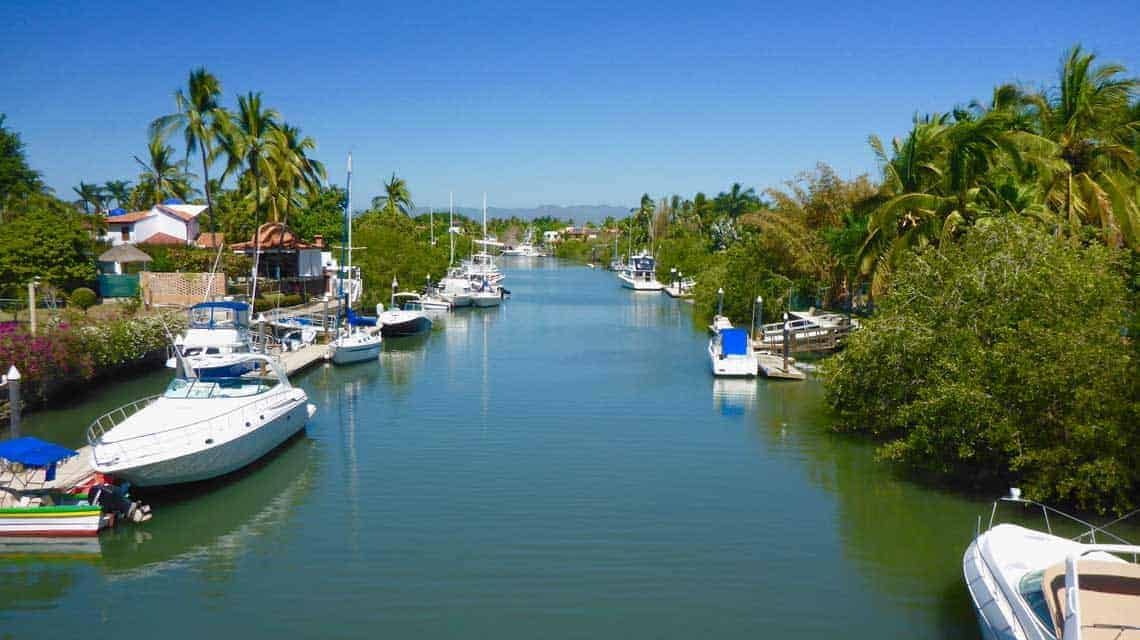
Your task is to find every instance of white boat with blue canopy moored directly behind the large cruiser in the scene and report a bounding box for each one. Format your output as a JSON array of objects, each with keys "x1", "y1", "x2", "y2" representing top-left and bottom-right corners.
[{"x1": 166, "y1": 300, "x2": 253, "y2": 376}]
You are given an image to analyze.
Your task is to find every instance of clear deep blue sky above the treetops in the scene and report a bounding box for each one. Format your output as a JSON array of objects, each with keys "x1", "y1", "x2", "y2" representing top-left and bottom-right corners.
[{"x1": 0, "y1": 0, "x2": 1140, "y2": 206}]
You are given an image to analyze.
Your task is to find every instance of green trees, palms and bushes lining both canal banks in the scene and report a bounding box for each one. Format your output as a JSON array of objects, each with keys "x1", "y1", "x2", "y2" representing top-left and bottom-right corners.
[{"x1": 0, "y1": 46, "x2": 1140, "y2": 512}]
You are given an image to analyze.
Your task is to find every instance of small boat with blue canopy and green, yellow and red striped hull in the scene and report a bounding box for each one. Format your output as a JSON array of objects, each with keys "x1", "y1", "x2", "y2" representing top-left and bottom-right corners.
[{"x1": 0, "y1": 437, "x2": 149, "y2": 537}]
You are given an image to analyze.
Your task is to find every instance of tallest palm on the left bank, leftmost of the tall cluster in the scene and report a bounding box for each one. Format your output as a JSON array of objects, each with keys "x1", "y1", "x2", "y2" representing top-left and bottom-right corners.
[{"x1": 150, "y1": 67, "x2": 222, "y2": 232}]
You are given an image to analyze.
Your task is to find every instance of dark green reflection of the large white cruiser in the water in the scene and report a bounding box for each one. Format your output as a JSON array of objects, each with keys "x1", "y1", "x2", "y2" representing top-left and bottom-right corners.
[{"x1": 99, "y1": 431, "x2": 319, "y2": 580}]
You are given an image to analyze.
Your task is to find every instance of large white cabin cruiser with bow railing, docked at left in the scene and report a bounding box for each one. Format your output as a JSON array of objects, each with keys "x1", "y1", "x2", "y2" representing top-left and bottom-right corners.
[{"x1": 87, "y1": 354, "x2": 316, "y2": 487}]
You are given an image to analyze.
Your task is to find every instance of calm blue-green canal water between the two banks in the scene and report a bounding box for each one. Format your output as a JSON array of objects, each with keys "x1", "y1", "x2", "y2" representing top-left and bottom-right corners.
[{"x1": 0, "y1": 260, "x2": 988, "y2": 639}]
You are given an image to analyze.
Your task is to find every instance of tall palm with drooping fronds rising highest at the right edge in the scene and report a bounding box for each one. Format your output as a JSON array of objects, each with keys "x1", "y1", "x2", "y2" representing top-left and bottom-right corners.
[{"x1": 1031, "y1": 44, "x2": 1140, "y2": 249}]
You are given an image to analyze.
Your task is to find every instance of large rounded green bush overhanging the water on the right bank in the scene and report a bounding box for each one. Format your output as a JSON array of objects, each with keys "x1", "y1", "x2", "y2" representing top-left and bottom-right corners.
[{"x1": 827, "y1": 221, "x2": 1140, "y2": 511}]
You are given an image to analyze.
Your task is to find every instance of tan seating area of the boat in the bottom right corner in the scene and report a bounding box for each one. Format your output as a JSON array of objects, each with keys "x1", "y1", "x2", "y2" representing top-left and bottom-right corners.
[{"x1": 1041, "y1": 560, "x2": 1140, "y2": 640}]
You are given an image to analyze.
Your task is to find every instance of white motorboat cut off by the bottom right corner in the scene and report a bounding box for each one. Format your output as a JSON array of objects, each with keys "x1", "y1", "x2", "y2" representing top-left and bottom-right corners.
[{"x1": 962, "y1": 488, "x2": 1140, "y2": 640}]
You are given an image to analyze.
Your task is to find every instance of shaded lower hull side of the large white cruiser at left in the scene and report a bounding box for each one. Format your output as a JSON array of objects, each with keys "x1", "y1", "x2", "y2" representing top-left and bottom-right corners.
[{"x1": 95, "y1": 395, "x2": 310, "y2": 487}]
